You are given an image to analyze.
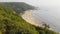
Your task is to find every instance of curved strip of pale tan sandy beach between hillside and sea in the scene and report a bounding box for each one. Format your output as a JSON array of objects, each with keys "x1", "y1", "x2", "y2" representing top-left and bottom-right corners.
[{"x1": 21, "y1": 10, "x2": 44, "y2": 27}]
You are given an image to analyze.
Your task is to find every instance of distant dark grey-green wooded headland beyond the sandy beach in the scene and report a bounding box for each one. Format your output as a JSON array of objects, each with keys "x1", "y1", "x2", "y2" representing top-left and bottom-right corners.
[{"x1": 2, "y1": 2, "x2": 36, "y2": 14}]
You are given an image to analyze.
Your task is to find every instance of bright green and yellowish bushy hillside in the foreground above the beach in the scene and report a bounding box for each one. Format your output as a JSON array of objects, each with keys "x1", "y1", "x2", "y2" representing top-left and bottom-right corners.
[{"x1": 0, "y1": 4, "x2": 57, "y2": 34}]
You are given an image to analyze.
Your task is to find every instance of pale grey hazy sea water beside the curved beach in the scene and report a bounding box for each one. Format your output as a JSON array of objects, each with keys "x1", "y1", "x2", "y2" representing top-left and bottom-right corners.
[{"x1": 32, "y1": 6, "x2": 60, "y2": 33}]
